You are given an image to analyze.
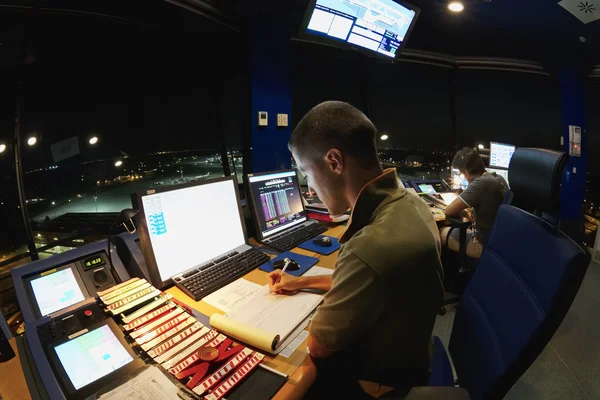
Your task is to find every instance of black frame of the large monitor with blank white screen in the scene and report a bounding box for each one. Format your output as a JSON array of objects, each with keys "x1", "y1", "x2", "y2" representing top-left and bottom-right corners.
[{"x1": 134, "y1": 176, "x2": 248, "y2": 289}]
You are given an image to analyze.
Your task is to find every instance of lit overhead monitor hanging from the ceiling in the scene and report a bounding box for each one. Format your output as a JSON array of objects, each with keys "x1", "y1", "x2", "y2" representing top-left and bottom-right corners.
[{"x1": 300, "y1": 0, "x2": 421, "y2": 60}]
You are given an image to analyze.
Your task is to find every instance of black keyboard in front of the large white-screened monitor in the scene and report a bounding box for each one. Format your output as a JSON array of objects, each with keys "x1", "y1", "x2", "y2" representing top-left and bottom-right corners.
[{"x1": 175, "y1": 249, "x2": 270, "y2": 301}]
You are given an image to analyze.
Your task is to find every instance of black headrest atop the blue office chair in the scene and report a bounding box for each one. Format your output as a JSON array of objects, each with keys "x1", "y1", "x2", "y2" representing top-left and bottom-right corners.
[{"x1": 508, "y1": 148, "x2": 569, "y2": 213}]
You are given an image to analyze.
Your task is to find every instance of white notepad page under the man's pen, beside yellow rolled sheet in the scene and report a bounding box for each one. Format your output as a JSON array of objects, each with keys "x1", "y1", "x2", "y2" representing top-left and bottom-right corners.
[{"x1": 228, "y1": 285, "x2": 323, "y2": 342}]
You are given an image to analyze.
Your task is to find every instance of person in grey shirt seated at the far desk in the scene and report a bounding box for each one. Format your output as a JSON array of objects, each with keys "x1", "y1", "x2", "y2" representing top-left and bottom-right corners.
[{"x1": 440, "y1": 147, "x2": 508, "y2": 258}]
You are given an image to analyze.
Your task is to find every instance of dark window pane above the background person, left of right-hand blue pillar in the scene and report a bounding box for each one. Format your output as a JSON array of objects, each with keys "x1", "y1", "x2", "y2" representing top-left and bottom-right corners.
[{"x1": 456, "y1": 70, "x2": 563, "y2": 150}]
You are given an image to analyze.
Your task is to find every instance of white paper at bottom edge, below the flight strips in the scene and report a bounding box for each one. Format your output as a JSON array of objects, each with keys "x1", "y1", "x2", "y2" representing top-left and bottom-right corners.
[{"x1": 99, "y1": 367, "x2": 181, "y2": 400}]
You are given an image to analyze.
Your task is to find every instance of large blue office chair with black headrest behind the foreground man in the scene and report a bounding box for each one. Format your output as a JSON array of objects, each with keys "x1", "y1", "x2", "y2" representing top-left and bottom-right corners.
[{"x1": 429, "y1": 149, "x2": 590, "y2": 399}]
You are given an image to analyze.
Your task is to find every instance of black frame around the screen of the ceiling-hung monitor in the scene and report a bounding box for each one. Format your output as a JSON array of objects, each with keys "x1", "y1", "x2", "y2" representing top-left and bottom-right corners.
[{"x1": 298, "y1": 0, "x2": 421, "y2": 62}]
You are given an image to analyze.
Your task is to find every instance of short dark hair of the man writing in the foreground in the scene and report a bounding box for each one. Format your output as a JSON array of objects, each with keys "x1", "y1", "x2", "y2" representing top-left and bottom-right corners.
[{"x1": 288, "y1": 101, "x2": 379, "y2": 168}]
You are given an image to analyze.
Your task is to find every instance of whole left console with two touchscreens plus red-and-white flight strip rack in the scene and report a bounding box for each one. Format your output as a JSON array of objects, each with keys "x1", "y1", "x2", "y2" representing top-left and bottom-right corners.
[{"x1": 12, "y1": 235, "x2": 278, "y2": 400}]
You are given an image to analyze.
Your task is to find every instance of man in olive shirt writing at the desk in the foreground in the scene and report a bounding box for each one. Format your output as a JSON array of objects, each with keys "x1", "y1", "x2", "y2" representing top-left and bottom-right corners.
[{"x1": 269, "y1": 101, "x2": 443, "y2": 399}]
